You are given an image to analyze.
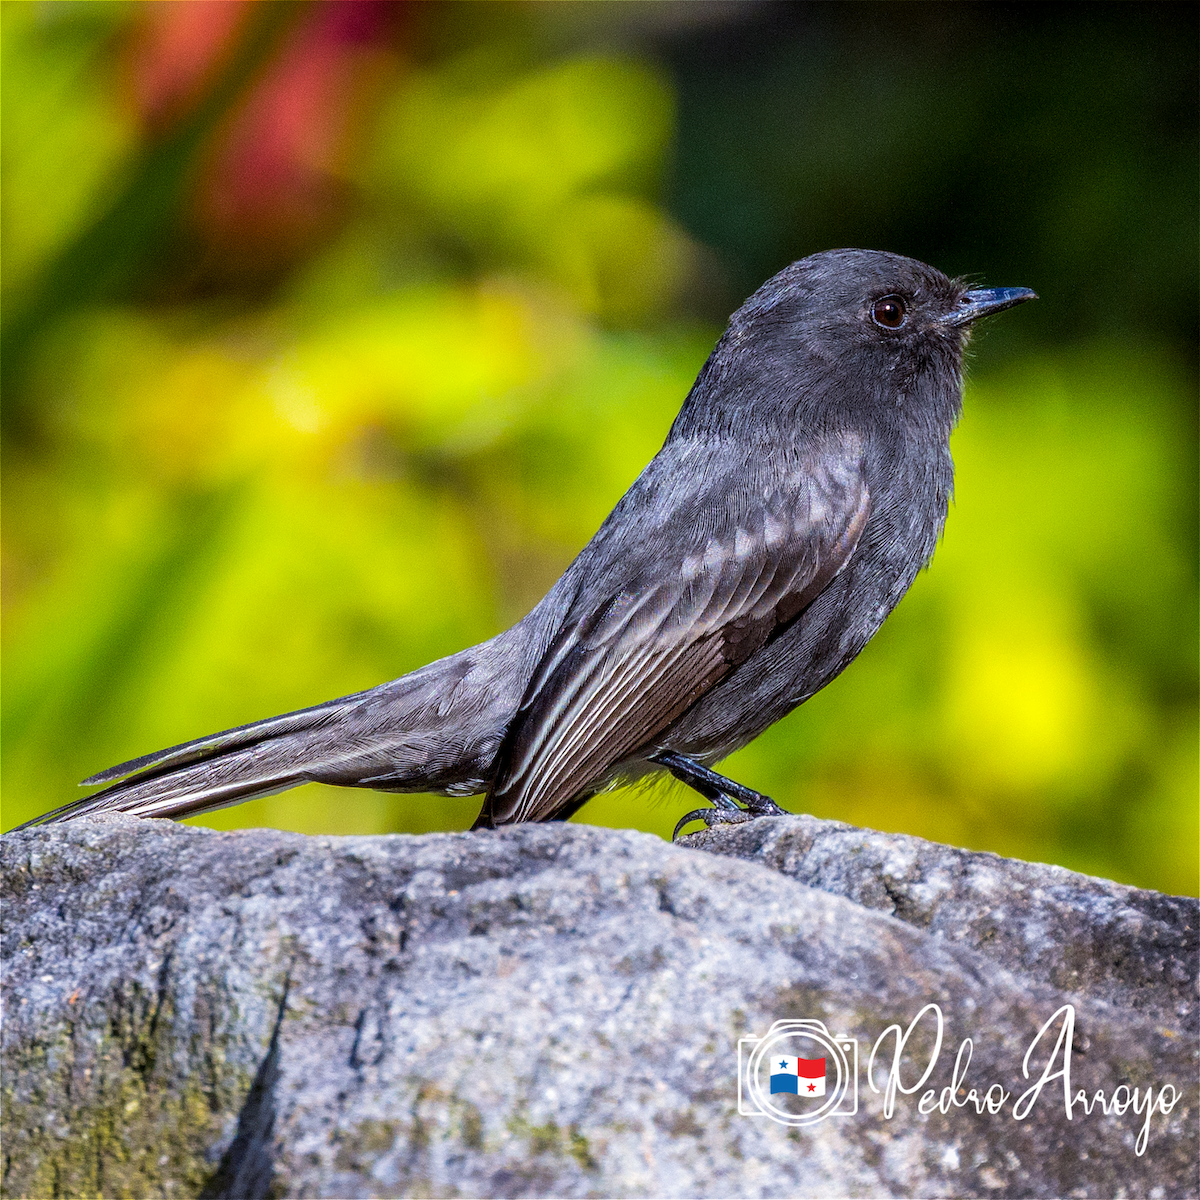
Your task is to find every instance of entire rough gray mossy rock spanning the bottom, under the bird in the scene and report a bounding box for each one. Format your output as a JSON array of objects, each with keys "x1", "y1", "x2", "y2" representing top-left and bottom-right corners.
[{"x1": 2, "y1": 816, "x2": 1200, "y2": 1198}]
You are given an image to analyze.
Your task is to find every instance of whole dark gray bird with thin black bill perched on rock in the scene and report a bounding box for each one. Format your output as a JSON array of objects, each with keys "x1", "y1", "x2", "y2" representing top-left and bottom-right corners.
[{"x1": 18, "y1": 250, "x2": 1036, "y2": 838}]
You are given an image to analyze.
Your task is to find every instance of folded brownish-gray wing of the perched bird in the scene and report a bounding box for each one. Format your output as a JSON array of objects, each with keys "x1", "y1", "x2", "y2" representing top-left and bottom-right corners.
[{"x1": 480, "y1": 446, "x2": 870, "y2": 824}]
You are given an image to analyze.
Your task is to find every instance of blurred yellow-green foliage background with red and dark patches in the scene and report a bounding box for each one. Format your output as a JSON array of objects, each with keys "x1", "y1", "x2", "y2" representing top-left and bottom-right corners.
[{"x1": 0, "y1": 0, "x2": 1200, "y2": 892}]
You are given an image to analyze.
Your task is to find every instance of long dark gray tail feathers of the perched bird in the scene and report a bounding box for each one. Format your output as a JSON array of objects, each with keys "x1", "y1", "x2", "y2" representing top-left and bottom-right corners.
[{"x1": 18, "y1": 640, "x2": 516, "y2": 828}]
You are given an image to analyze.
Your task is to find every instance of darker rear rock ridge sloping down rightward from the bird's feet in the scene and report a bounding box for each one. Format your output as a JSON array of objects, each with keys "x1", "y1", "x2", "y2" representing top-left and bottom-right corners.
[{"x1": 685, "y1": 816, "x2": 1200, "y2": 1034}]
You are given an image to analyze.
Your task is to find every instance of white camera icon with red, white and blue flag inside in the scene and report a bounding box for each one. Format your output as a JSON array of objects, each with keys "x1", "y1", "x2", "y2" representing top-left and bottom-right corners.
[{"x1": 738, "y1": 1021, "x2": 858, "y2": 1126}]
